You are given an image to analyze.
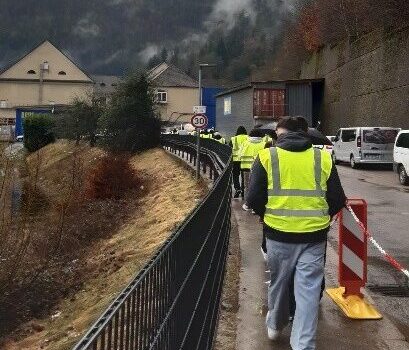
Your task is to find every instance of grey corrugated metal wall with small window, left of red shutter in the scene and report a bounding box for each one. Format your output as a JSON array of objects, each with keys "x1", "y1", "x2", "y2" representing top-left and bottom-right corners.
[{"x1": 216, "y1": 88, "x2": 254, "y2": 138}]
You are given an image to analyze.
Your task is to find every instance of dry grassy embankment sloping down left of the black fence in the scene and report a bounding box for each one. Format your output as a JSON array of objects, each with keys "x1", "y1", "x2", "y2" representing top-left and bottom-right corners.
[{"x1": 0, "y1": 141, "x2": 205, "y2": 350}]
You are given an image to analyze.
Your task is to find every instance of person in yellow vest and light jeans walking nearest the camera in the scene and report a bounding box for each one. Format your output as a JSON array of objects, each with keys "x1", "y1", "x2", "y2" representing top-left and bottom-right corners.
[{"x1": 247, "y1": 117, "x2": 346, "y2": 350}]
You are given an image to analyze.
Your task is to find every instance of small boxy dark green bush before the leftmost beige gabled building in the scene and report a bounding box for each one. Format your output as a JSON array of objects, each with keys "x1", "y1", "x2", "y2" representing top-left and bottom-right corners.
[{"x1": 24, "y1": 114, "x2": 55, "y2": 152}]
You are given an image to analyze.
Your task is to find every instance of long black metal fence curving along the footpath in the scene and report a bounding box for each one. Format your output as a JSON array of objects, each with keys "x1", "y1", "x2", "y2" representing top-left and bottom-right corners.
[{"x1": 74, "y1": 135, "x2": 231, "y2": 350}]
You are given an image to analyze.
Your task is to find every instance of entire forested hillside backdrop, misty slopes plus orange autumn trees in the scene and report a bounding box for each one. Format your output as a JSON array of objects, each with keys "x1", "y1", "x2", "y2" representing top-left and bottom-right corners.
[{"x1": 0, "y1": 0, "x2": 409, "y2": 84}]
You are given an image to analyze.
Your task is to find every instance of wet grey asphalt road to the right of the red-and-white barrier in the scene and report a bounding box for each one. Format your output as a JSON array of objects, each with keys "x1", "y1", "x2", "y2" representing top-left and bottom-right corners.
[{"x1": 330, "y1": 164, "x2": 409, "y2": 339}]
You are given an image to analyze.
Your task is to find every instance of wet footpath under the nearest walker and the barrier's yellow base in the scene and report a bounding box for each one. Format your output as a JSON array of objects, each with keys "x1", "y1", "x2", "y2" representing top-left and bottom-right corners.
[{"x1": 232, "y1": 201, "x2": 409, "y2": 350}]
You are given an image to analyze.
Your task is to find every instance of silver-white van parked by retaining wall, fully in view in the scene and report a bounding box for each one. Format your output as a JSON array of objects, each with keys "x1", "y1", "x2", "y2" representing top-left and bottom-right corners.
[{"x1": 333, "y1": 127, "x2": 400, "y2": 169}]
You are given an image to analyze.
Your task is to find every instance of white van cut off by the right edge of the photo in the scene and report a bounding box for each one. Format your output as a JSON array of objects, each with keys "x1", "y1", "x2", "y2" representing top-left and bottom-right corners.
[{"x1": 393, "y1": 130, "x2": 409, "y2": 185}]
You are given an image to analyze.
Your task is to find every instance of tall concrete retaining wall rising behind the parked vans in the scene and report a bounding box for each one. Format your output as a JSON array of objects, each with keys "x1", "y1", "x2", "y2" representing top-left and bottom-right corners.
[{"x1": 300, "y1": 27, "x2": 409, "y2": 134}]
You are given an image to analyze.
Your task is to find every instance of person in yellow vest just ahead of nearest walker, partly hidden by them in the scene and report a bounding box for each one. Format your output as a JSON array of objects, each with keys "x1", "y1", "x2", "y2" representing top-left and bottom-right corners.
[{"x1": 239, "y1": 129, "x2": 266, "y2": 211}]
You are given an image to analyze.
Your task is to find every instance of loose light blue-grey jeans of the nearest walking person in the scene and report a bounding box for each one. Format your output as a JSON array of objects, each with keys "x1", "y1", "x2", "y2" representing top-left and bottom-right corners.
[{"x1": 266, "y1": 239, "x2": 326, "y2": 350}]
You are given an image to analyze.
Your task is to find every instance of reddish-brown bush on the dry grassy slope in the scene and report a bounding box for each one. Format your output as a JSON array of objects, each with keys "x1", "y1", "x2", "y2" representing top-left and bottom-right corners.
[{"x1": 85, "y1": 154, "x2": 142, "y2": 199}]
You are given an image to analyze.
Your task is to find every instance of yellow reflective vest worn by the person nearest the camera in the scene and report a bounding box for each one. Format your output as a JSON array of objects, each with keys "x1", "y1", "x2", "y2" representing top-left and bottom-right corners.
[{"x1": 259, "y1": 147, "x2": 332, "y2": 234}]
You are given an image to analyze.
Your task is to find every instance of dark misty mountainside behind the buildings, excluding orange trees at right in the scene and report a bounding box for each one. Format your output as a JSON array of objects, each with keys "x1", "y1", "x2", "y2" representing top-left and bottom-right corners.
[{"x1": 0, "y1": 0, "x2": 295, "y2": 80}]
